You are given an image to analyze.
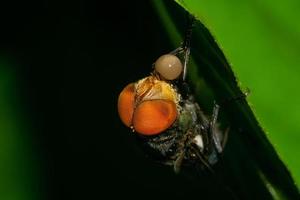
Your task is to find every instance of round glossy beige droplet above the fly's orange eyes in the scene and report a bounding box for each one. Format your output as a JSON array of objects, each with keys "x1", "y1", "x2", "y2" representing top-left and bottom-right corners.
[{"x1": 155, "y1": 54, "x2": 183, "y2": 80}]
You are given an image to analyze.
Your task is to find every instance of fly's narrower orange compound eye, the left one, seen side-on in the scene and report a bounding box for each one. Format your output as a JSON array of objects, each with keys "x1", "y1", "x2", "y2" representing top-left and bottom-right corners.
[{"x1": 118, "y1": 83, "x2": 135, "y2": 127}]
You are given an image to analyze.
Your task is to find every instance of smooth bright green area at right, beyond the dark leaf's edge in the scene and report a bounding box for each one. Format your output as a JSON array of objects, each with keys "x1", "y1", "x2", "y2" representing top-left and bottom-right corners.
[{"x1": 178, "y1": 0, "x2": 300, "y2": 187}]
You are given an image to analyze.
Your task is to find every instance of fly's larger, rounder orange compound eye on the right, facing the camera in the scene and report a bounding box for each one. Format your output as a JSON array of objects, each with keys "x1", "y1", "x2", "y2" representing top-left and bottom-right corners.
[{"x1": 133, "y1": 100, "x2": 177, "y2": 135}]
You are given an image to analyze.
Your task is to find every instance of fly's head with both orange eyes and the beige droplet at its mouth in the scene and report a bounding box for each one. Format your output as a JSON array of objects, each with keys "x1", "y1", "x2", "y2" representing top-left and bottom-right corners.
[{"x1": 118, "y1": 55, "x2": 182, "y2": 136}]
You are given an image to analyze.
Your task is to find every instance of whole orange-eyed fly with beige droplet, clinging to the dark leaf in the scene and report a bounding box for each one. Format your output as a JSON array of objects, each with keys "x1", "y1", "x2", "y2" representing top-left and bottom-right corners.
[{"x1": 118, "y1": 18, "x2": 227, "y2": 173}]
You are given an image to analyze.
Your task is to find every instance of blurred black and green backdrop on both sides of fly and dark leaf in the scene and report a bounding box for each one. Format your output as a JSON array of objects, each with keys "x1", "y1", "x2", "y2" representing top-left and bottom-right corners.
[{"x1": 0, "y1": 0, "x2": 300, "y2": 200}]
